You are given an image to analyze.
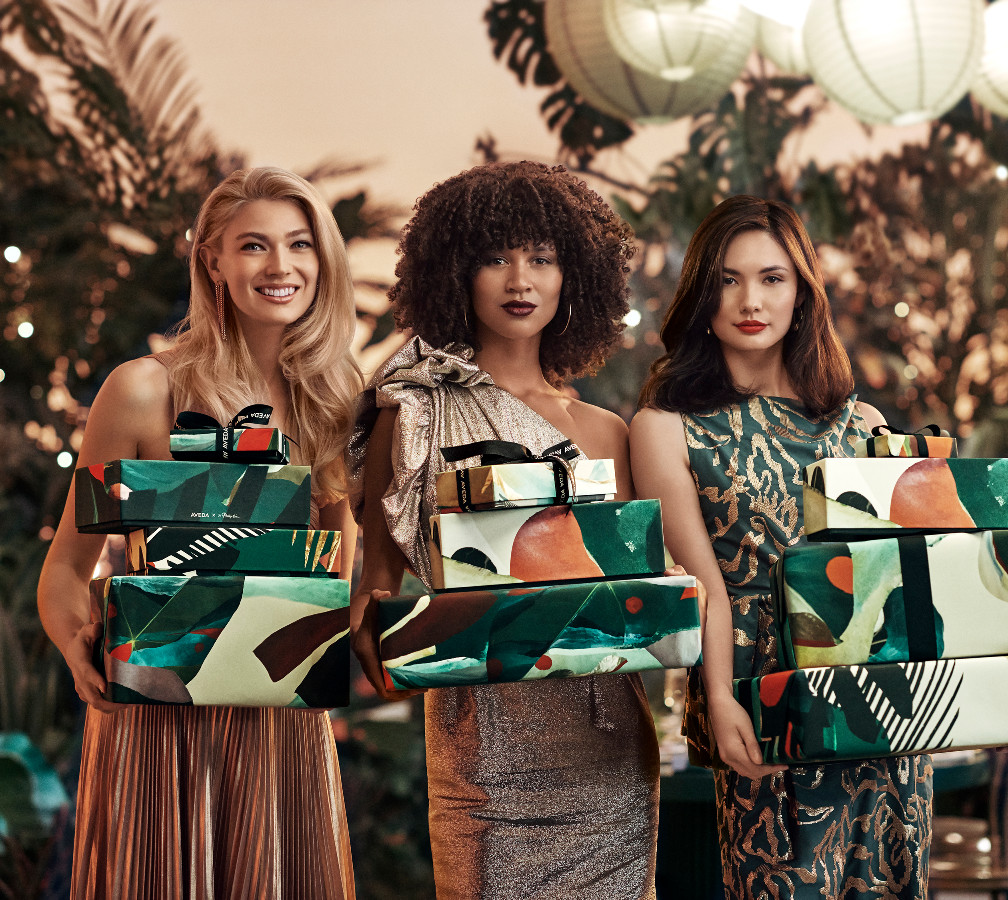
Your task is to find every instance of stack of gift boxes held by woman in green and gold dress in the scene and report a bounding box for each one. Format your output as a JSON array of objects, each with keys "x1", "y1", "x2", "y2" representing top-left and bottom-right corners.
[{"x1": 735, "y1": 427, "x2": 1008, "y2": 763}]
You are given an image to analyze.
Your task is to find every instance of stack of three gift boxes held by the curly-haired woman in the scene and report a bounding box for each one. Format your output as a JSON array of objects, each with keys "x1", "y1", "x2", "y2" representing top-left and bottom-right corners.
[{"x1": 379, "y1": 441, "x2": 701, "y2": 689}]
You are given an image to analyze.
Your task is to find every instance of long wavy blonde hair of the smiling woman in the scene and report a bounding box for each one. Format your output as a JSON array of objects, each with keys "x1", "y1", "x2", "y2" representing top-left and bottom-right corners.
[{"x1": 160, "y1": 166, "x2": 363, "y2": 504}]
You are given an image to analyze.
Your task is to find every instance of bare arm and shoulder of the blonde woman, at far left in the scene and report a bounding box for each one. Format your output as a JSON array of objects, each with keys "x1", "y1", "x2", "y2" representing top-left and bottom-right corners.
[{"x1": 38, "y1": 359, "x2": 170, "y2": 712}]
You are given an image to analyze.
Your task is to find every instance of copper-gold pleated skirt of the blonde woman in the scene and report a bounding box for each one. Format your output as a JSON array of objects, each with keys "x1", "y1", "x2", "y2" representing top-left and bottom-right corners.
[{"x1": 72, "y1": 705, "x2": 354, "y2": 900}]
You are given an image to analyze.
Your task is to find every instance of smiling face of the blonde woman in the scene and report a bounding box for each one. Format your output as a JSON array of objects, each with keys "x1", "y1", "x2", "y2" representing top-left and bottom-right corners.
[{"x1": 202, "y1": 200, "x2": 319, "y2": 329}]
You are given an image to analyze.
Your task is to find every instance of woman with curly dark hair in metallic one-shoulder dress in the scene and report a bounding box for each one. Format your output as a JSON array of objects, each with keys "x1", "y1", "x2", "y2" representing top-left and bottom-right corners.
[{"x1": 348, "y1": 162, "x2": 658, "y2": 900}]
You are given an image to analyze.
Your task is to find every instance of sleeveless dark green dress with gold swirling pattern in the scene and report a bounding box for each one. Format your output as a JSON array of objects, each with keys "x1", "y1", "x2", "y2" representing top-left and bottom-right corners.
[{"x1": 682, "y1": 396, "x2": 931, "y2": 900}]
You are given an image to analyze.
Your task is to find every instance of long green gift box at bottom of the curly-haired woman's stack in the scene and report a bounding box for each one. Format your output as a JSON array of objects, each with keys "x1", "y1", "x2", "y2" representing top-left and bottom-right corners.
[{"x1": 378, "y1": 575, "x2": 701, "y2": 688}]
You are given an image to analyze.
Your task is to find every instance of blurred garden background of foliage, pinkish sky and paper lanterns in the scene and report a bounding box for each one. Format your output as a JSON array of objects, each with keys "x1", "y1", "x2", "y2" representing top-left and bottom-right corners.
[{"x1": 0, "y1": 0, "x2": 1008, "y2": 898}]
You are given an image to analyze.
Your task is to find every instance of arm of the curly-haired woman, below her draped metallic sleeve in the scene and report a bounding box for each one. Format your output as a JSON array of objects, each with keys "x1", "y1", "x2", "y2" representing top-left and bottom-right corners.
[{"x1": 350, "y1": 408, "x2": 422, "y2": 700}]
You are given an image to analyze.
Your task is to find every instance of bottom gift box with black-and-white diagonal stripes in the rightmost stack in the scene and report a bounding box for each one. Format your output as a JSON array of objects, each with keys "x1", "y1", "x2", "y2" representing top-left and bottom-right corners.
[{"x1": 734, "y1": 656, "x2": 1008, "y2": 763}]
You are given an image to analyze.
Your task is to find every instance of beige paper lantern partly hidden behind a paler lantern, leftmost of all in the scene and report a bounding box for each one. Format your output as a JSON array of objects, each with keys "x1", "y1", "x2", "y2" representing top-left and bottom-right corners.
[{"x1": 544, "y1": 0, "x2": 756, "y2": 122}]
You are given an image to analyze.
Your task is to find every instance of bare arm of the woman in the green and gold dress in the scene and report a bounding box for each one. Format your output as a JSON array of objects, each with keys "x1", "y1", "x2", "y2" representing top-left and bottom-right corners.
[{"x1": 630, "y1": 409, "x2": 782, "y2": 778}]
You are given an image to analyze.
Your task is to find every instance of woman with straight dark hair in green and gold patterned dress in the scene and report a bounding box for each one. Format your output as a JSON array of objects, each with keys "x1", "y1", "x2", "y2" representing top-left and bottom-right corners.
[{"x1": 630, "y1": 197, "x2": 931, "y2": 898}]
